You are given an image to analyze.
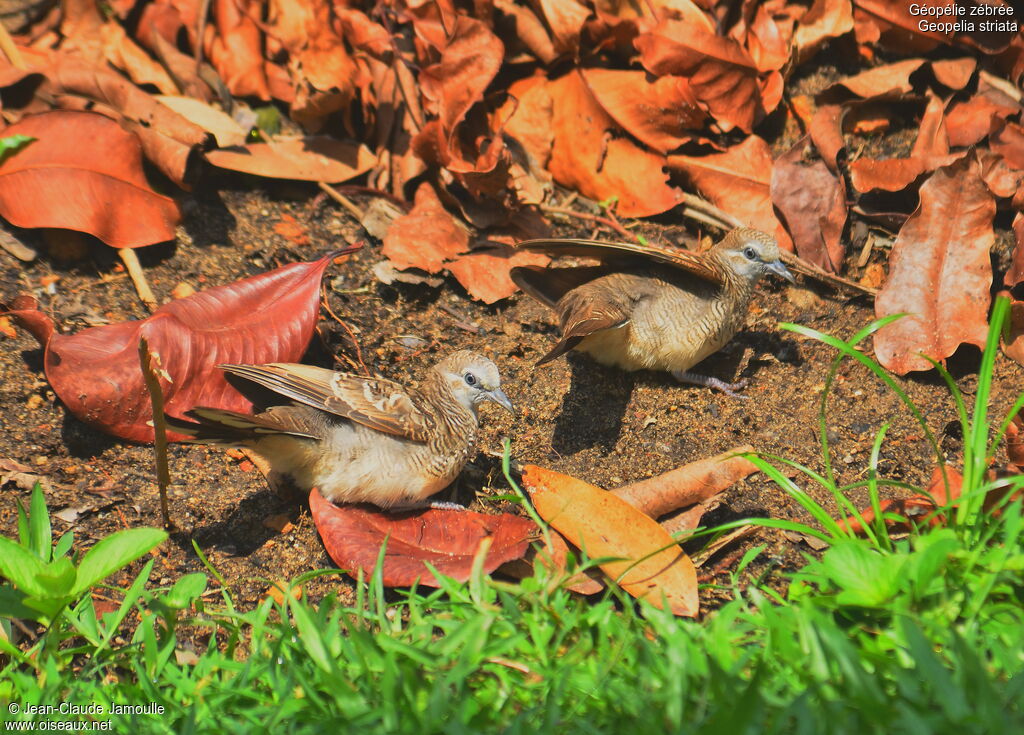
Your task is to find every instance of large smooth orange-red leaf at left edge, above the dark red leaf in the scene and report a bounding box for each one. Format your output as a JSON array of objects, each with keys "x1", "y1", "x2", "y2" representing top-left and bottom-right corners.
[{"x1": 0, "y1": 111, "x2": 179, "y2": 248}]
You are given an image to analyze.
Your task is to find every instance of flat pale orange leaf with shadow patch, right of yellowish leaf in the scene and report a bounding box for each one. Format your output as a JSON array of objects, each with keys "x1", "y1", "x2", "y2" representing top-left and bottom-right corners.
[{"x1": 206, "y1": 135, "x2": 377, "y2": 183}]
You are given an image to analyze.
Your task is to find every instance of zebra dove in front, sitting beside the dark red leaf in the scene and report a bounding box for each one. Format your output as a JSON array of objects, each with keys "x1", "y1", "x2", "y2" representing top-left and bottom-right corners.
[{"x1": 168, "y1": 350, "x2": 513, "y2": 509}]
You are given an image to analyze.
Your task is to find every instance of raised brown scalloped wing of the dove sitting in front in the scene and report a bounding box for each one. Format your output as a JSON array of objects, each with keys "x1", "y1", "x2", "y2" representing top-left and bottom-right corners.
[{"x1": 218, "y1": 362, "x2": 431, "y2": 442}]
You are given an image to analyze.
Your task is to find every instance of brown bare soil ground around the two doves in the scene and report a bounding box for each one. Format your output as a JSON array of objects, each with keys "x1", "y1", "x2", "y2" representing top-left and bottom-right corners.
[{"x1": 0, "y1": 170, "x2": 1021, "y2": 607}]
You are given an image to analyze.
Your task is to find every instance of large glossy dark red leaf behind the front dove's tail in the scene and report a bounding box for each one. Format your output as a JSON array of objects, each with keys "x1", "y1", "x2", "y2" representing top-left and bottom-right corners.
[{"x1": 7, "y1": 248, "x2": 357, "y2": 441}]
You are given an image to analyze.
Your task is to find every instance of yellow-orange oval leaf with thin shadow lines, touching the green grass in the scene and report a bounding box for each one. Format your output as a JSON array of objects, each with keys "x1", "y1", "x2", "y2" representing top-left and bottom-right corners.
[{"x1": 522, "y1": 465, "x2": 699, "y2": 617}]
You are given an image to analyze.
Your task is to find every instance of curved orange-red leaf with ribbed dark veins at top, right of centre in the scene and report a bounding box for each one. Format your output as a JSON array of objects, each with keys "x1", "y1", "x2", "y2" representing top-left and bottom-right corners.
[{"x1": 634, "y1": 20, "x2": 765, "y2": 133}]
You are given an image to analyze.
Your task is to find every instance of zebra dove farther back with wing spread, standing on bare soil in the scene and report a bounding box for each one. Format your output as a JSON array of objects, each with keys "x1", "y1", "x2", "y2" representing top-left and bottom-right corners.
[{"x1": 511, "y1": 227, "x2": 793, "y2": 395}]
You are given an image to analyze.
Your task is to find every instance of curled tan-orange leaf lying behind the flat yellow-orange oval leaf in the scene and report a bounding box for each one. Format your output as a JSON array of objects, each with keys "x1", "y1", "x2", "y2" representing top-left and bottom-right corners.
[{"x1": 611, "y1": 444, "x2": 758, "y2": 518}]
